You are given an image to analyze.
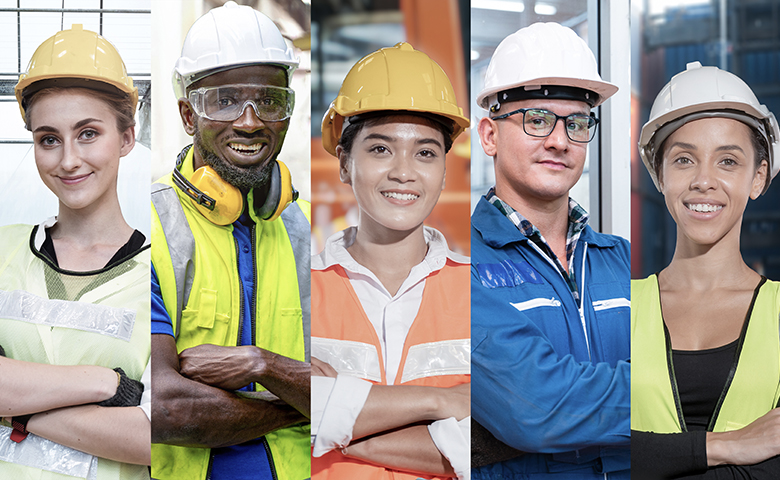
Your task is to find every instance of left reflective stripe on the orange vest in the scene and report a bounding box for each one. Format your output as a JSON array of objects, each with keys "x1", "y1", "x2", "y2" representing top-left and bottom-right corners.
[{"x1": 311, "y1": 337, "x2": 382, "y2": 382}]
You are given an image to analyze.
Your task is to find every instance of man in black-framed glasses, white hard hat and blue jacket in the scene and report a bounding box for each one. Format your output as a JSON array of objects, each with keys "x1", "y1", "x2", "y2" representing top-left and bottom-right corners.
[{"x1": 471, "y1": 23, "x2": 630, "y2": 480}]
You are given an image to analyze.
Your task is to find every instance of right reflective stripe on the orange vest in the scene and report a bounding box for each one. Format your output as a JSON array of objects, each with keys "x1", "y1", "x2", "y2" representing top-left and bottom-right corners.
[{"x1": 401, "y1": 338, "x2": 471, "y2": 383}]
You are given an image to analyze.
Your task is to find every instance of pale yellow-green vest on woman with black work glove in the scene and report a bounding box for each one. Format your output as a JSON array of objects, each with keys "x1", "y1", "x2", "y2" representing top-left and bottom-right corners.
[{"x1": 0, "y1": 225, "x2": 151, "y2": 480}]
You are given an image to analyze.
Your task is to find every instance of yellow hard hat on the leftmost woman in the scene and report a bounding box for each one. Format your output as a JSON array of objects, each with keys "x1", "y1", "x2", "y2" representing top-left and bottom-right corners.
[{"x1": 14, "y1": 24, "x2": 138, "y2": 123}]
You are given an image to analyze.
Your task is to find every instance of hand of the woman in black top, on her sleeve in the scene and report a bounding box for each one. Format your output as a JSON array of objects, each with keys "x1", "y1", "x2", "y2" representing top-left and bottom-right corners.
[{"x1": 707, "y1": 408, "x2": 780, "y2": 466}]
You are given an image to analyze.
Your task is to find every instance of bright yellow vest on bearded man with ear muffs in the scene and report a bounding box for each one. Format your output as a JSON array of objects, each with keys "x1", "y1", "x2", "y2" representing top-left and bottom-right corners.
[{"x1": 152, "y1": 149, "x2": 311, "y2": 480}]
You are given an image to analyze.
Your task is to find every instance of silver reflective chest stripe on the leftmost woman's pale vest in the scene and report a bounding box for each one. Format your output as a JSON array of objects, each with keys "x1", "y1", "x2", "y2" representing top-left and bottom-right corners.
[{"x1": 0, "y1": 290, "x2": 135, "y2": 342}]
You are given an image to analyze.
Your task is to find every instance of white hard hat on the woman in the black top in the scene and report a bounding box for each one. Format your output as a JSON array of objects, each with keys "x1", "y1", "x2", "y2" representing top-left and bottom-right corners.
[{"x1": 639, "y1": 62, "x2": 780, "y2": 193}]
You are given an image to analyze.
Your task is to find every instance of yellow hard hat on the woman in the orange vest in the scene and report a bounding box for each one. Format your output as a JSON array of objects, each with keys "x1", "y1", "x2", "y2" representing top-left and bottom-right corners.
[{"x1": 322, "y1": 42, "x2": 469, "y2": 156}]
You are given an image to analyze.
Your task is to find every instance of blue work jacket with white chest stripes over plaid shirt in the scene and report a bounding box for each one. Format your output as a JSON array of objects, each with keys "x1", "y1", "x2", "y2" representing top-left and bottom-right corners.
[{"x1": 471, "y1": 197, "x2": 631, "y2": 480}]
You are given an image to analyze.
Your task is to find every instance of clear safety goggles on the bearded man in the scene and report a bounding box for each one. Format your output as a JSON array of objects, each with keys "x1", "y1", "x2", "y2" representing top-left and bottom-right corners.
[{"x1": 189, "y1": 84, "x2": 295, "y2": 122}]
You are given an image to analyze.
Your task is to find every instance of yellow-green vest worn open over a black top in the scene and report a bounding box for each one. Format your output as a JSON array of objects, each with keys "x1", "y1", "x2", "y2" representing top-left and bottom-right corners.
[{"x1": 631, "y1": 275, "x2": 780, "y2": 433}]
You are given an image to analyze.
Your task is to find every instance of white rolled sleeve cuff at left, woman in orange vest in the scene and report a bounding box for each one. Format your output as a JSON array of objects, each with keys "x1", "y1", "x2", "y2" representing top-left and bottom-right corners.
[{"x1": 312, "y1": 375, "x2": 371, "y2": 457}]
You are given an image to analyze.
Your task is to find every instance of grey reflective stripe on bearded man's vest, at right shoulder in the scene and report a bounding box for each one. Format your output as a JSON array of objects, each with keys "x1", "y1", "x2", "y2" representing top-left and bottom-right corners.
[{"x1": 282, "y1": 202, "x2": 311, "y2": 362}]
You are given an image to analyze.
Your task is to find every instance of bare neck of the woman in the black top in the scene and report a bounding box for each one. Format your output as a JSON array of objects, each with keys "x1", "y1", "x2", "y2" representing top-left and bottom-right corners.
[{"x1": 661, "y1": 225, "x2": 758, "y2": 291}]
